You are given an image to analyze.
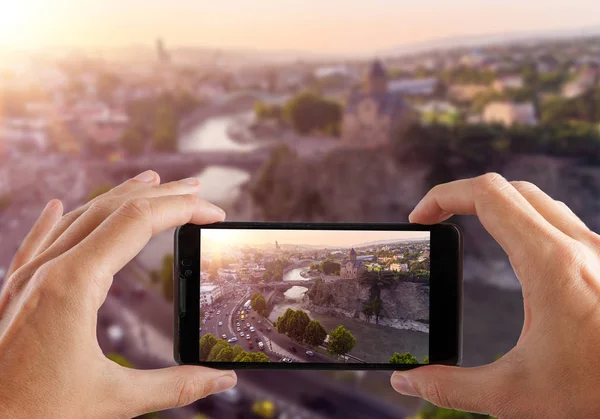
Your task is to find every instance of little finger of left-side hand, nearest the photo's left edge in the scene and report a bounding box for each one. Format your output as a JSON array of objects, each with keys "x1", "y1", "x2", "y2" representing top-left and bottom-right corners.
[{"x1": 6, "y1": 199, "x2": 63, "y2": 278}]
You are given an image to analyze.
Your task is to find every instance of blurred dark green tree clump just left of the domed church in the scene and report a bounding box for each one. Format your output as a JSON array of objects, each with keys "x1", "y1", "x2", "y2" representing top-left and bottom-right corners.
[{"x1": 283, "y1": 92, "x2": 342, "y2": 135}]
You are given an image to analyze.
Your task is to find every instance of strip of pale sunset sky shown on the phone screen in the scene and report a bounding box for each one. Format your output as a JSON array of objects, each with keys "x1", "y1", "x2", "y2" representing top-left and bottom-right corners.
[{"x1": 200, "y1": 229, "x2": 429, "y2": 247}]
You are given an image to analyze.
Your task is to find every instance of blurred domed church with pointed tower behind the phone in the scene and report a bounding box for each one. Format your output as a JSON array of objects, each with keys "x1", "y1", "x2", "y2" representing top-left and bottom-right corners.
[{"x1": 342, "y1": 60, "x2": 417, "y2": 148}]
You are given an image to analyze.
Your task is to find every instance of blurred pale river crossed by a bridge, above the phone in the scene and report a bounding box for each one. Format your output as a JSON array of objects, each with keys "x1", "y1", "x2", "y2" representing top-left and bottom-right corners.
[{"x1": 179, "y1": 112, "x2": 256, "y2": 203}]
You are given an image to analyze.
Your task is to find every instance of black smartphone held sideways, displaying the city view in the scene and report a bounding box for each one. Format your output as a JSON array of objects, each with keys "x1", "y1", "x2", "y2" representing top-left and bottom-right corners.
[{"x1": 174, "y1": 222, "x2": 463, "y2": 370}]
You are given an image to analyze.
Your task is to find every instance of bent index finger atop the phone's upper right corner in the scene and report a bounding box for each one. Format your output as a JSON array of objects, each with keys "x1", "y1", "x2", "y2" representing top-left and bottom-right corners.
[{"x1": 409, "y1": 173, "x2": 564, "y2": 265}]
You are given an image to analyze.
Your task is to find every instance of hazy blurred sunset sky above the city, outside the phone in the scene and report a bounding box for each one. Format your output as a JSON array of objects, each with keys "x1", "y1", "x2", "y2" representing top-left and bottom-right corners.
[{"x1": 0, "y1": 0, "x2": 600, "y2": 53}]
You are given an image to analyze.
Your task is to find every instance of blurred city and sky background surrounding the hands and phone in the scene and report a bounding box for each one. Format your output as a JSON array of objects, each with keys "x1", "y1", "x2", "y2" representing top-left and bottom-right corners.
[{"x1": 0, "y1": 0, "x2": 600, "y2": 419}]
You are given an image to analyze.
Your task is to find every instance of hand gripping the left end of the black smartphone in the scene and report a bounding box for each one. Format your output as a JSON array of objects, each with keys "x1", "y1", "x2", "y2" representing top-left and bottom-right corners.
[{"x1": 0, "y1": 171, "x2": 236, "y2": 419}]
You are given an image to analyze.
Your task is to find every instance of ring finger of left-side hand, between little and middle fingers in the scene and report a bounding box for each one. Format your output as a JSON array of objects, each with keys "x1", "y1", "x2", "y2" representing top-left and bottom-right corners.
[{"x1": 34, "y1": 170, "x2": 160, "y2": 256}]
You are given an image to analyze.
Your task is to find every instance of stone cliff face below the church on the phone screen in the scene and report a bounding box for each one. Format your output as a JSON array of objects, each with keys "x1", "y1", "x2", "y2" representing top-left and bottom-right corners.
[{"x1": 303, "y1": 279, "x2": 429, "y2": 332}]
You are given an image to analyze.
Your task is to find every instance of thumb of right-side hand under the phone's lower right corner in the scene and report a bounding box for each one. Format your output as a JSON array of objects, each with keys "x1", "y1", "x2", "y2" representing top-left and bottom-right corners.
[{"x1": 391, "y1": 363, "x2": 506, "y2": 414}]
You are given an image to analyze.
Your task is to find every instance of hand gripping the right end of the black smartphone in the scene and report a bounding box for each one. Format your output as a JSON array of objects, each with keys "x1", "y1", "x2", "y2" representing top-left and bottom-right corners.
[{"x1": 392, "y1": 174, "x2": 600, "y2": 418}]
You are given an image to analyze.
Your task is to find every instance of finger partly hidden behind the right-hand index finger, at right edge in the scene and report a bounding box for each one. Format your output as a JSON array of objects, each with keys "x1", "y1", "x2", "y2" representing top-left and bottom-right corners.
[{"x1": 510, "y1": 181, "x2": 590, "y2": 240}]
